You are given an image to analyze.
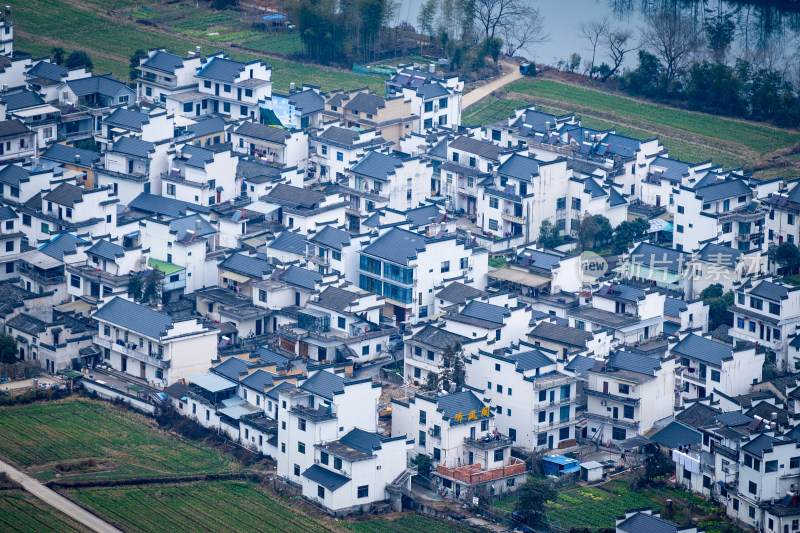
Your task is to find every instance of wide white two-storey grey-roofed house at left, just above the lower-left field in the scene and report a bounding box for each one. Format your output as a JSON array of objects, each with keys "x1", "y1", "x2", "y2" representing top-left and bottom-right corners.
[{"x1": 92, "y1": 297, "x2": 217, "y2": 386}]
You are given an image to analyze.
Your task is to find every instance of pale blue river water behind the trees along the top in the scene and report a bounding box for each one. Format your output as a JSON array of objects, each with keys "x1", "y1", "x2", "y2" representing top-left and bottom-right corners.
[{"x1": 396, "y1": 0, "x2": 800, "y2": 67}]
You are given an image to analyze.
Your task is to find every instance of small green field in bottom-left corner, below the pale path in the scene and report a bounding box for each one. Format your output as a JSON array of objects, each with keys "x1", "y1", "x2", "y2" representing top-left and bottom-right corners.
[{"x1": 0, "y1": 490, "x2": 89, "y2": 533}]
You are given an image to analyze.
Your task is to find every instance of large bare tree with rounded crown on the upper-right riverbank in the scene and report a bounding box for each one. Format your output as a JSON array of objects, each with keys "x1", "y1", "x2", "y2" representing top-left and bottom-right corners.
[{"x1": 642, "y1": 11, "x2": 703, "y2": 83}]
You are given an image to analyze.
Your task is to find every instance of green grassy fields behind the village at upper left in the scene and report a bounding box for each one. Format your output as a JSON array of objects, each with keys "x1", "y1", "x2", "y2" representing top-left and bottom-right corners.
[{"x1": 14, "y1": 0, "x2": 384, "y2": 94}]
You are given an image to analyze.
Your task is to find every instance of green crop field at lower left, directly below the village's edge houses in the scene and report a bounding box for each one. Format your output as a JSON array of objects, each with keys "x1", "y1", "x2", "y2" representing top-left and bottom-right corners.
[{"x1": 0, "y1": 399, "x2": 238, "y2": 479}]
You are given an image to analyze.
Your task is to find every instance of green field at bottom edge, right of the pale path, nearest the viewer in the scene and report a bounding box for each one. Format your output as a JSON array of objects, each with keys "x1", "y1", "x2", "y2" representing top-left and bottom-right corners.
[{"x1": 69, "y1": 481, "x2": 333, "y2": 533}]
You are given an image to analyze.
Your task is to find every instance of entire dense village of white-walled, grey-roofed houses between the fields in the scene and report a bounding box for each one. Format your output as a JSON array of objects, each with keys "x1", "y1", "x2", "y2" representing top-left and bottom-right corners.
[{"x1": 0, "y1": 10, "x2": 800, "y2": 520}]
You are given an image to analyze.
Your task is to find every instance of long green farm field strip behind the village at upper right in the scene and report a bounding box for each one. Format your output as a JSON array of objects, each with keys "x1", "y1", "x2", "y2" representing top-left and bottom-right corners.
[{"x1": 508, "y1": 79, "x2": 800, "y2": 175}]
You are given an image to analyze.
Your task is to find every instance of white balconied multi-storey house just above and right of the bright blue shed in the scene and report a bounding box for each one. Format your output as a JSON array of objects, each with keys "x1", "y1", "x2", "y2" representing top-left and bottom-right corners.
[{"x1": 584, "y1": 352, "x2": 675, "y2": 443}]
